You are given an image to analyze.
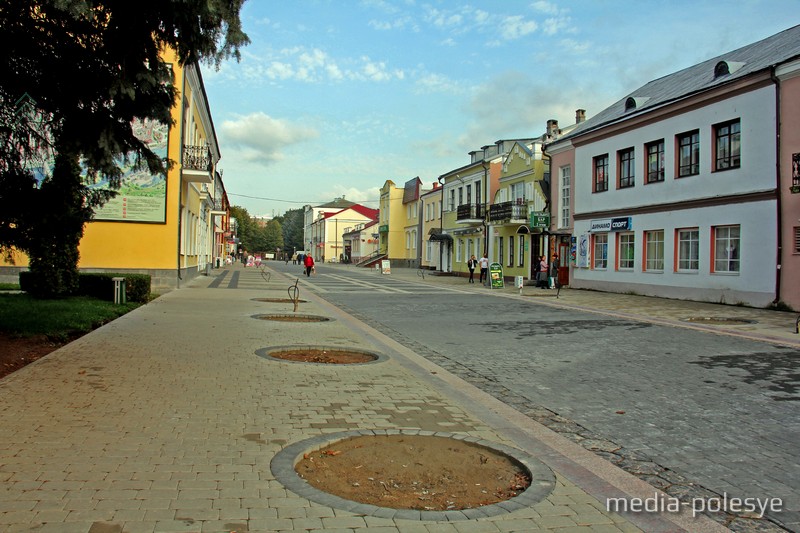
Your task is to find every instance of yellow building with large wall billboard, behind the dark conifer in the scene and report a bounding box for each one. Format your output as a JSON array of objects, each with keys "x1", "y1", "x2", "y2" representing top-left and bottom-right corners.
[{"x1": 0, "y1": 52, "x2": 228, "y2": 291}]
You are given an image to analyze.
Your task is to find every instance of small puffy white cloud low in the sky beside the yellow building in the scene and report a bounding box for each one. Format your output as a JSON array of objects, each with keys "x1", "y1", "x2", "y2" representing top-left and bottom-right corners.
[{"x1": 220, "y1": 112, "x2": 319, "y2": 163}]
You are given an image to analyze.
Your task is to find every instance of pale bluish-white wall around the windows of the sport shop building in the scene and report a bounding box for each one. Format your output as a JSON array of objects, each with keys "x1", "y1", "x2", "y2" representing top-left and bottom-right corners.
[{"x1": 573, "y1": 87, "x2": 777, "y2": 306}]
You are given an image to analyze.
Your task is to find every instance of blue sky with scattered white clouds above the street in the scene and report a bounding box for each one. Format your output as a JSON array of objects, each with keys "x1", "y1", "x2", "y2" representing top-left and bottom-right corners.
[{"x1": 202, "y1": 0, "x2": 800, "y2": 216}]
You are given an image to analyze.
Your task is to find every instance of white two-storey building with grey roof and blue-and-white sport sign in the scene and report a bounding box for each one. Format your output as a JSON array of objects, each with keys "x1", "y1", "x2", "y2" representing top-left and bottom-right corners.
[{"x1": 548, "y1": 27, "x2": 800, "y2": 307}]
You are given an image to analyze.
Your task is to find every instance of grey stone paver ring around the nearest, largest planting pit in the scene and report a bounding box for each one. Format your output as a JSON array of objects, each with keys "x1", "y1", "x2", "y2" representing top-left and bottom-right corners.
[{"x1": 270, "y1": 429, "x2": 556, "y2": 522}]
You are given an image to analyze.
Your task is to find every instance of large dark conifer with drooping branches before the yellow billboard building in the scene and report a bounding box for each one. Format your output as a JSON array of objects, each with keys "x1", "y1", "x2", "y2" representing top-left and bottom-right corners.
[{"x1": 0, "y1": 0, "x2": 249, "y2": 296}]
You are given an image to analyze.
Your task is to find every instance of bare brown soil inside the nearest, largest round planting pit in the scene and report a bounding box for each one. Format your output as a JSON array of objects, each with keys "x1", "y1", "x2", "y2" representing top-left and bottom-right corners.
[{"x1": 295, "y1": 435, "x2": 531, "y2": 511}]
